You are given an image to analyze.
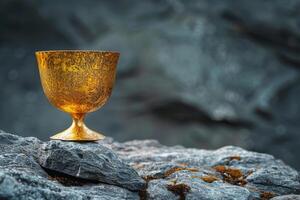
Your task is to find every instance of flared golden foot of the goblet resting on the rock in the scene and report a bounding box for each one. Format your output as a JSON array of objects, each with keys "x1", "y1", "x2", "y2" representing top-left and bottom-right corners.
[{"x1": 50, "y1": 125, "x2": 105, "y2": 142}]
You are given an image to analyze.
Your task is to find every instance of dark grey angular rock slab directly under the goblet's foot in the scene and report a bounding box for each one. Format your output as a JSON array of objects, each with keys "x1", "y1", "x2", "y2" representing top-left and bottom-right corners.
[{"x1": 39, "y1": 141, "x2": 145, "y2": 190}]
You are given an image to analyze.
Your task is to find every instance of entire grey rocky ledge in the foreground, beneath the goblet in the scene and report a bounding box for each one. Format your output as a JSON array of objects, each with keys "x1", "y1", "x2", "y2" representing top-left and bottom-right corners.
[{"x1": 0, "y1": 131, "x2": 300, "y2": 200}]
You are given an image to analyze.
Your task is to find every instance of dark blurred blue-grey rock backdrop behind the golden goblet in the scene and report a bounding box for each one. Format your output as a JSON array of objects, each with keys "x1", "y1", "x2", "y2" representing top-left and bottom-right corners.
[{"x1": 0, "y1": 0, "x2": 300, "y2": 169}]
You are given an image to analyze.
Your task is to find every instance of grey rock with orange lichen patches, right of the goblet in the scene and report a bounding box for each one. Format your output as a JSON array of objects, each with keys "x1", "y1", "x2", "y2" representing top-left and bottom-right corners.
[{"x1": 109, "y1": 140, "x2": 300, "y2": 199}]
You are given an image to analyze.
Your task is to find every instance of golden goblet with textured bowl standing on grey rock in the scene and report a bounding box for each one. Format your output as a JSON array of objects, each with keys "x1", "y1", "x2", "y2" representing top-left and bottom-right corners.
[{"x1": 35, "y1": 50, "x2": 119, "y2": 141}]
